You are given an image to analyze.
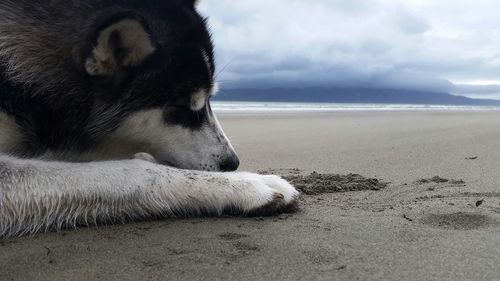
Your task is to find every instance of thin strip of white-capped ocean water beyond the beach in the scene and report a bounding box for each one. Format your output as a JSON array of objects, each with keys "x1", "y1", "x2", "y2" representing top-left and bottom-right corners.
[{"x1": 212, "y1": 101, "x2": 500, "y2": 113}]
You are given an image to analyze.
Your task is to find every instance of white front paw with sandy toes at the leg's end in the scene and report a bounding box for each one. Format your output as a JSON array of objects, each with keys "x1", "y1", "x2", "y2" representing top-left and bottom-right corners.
[{"x1": 228, "y1": 174, "x2": 300, "y2": 216}]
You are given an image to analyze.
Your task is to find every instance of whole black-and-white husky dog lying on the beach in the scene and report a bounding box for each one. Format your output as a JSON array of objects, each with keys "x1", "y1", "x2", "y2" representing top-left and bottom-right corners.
[{"x1": 0, "y1": 0, "x2": 298, "y2": 237}]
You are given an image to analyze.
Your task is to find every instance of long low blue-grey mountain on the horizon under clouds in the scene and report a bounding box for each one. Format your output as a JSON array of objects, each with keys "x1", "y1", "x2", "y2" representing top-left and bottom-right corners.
[{"x1": 215, "y1": 88, "x2": 500, "y2": 105}]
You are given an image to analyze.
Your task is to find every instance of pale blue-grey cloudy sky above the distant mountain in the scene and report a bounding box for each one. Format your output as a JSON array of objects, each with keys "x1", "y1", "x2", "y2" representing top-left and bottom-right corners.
[{"x1": 199, "y1": 0, "x2": 500, "y2": 99}]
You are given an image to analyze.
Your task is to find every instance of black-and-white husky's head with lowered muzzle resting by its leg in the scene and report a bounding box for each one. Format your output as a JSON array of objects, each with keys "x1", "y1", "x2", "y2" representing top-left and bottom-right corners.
[{"x1": 79, "y1": 0, "x2": 239, "y2": 171}]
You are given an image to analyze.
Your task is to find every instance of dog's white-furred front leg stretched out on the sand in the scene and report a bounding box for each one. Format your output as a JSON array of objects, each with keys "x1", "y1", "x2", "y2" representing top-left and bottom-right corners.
[{"x1": 0, "y1": 157, "x2": 298, "y2": 236}]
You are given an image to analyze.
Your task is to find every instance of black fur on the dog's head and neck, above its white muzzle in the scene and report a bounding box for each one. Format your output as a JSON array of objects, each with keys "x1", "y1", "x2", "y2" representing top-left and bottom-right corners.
[{"x1": 0, "y1": 0, "x2": 240, "y2": 171}]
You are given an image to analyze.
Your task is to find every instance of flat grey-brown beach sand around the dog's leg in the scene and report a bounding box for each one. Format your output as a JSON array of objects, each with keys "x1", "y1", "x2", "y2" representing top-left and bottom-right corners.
[{"x1": 0, "y1": 112, "x2": 500, "y2": 281}]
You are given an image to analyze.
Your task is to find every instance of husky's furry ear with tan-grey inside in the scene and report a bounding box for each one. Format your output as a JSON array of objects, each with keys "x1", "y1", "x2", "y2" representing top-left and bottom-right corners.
[{"x1": 85, "y1": 15, "x2": 155, "y2": 77}]
